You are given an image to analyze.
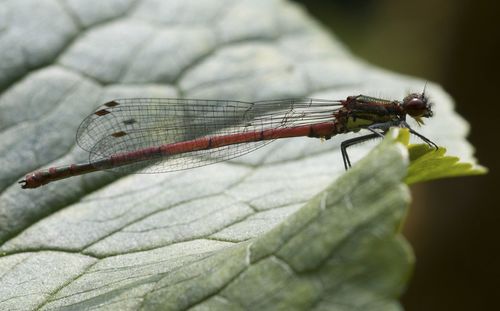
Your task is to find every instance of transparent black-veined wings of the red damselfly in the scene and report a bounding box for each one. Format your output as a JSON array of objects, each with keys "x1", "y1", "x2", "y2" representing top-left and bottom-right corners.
[{"x1": 77, "y1": 98, "x2": 341, "y2": 173}]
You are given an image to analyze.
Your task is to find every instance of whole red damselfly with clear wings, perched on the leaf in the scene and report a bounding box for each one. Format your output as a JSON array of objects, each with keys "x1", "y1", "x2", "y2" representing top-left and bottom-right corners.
[{"x1": 19, "y1": 90, "x2": 438, "y2": 189}]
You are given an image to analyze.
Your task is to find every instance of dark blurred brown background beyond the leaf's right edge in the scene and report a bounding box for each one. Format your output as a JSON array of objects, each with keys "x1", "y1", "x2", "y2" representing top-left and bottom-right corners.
[{"x1": 296, "y1": 0, "x2": 500, "y2": 310}]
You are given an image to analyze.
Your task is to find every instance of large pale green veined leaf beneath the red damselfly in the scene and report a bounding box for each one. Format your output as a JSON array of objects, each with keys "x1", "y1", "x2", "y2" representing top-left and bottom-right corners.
[{"x1": 0, "y1": 0, "x2": 473, "y2": 310}]
